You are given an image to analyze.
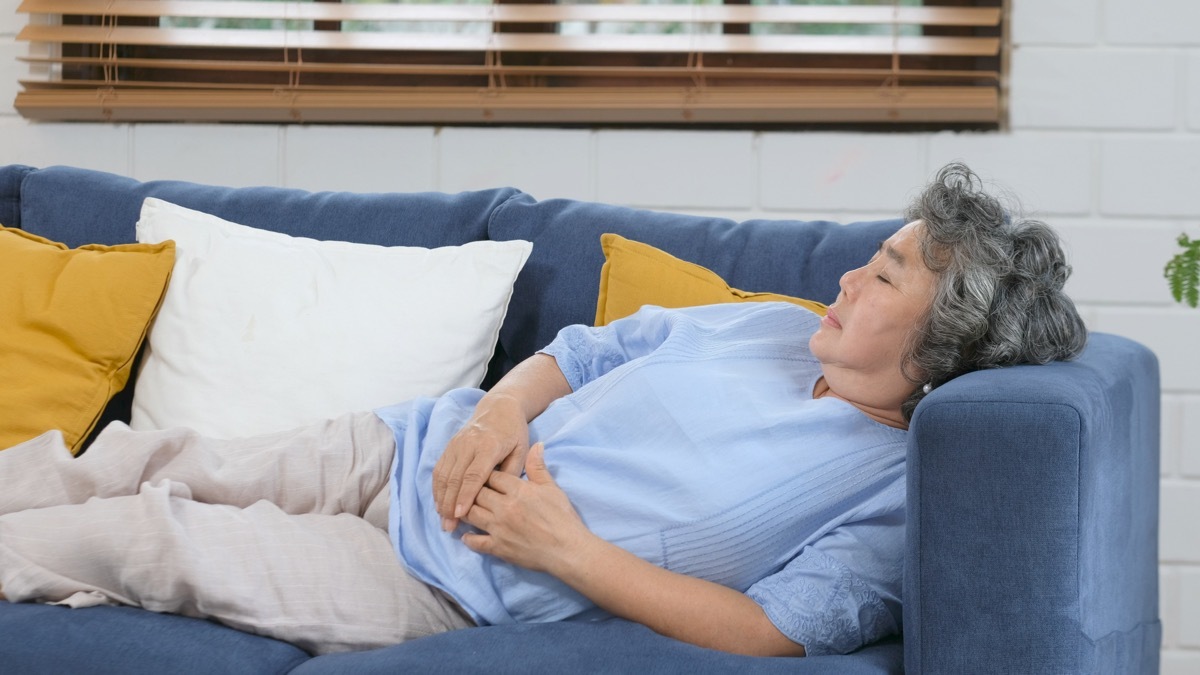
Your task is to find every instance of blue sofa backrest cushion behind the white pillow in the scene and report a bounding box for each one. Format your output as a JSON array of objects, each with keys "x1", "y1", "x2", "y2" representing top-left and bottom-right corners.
[{"x1": 0, "y1": 167, "x2": 517, "y2": 247}]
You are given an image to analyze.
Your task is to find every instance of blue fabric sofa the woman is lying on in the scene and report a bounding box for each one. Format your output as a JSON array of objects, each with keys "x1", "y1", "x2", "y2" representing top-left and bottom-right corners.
[{"x1": 0, "y1": 166, "x2": 1160, "y2": 675}]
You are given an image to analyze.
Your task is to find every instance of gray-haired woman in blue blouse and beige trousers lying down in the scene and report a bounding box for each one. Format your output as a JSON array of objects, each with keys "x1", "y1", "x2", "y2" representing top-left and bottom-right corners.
[{"x1": 0, "y1": 165, "x2": 1085, "y2": 655}]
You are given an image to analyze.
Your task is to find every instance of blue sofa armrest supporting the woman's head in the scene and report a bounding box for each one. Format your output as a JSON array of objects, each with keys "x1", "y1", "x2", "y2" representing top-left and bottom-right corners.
[{"x1": 904, "y1": 334, "x2": 1162, "y2": 674}]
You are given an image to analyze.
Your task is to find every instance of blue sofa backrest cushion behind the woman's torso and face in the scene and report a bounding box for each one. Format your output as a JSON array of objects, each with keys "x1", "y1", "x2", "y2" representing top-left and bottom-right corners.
[{"x1": 488, "y1": 193, "x2": 902, "y2": 375}]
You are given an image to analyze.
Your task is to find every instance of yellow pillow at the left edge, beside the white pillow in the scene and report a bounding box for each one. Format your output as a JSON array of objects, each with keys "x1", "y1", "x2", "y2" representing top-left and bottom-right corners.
[{"x1": 0, "y1": 226, "x2": 175, "y2": 454}]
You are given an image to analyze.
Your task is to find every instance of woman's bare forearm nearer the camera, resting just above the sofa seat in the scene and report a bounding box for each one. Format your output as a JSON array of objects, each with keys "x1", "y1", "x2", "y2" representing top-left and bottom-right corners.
[{"x1": 547, "y1": 533, "x2": 804, "y2": 656}]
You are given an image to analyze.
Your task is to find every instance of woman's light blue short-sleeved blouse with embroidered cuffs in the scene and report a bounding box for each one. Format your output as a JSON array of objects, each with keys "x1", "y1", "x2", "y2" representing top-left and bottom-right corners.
[{"x1": 376, "y1": 303, "x2": 907, "y2": 656}]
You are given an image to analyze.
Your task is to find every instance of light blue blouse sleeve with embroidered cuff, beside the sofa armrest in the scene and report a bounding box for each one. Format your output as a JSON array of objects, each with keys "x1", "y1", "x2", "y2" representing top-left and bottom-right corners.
[{"x1": 746, "y1": 503, "x2": 905, "y2": 656}]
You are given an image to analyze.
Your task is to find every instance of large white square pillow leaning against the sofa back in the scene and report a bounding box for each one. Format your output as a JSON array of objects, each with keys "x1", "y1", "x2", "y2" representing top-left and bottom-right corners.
[{"x1": 130, "y1": 198, "x2": 533, "y2": 438}]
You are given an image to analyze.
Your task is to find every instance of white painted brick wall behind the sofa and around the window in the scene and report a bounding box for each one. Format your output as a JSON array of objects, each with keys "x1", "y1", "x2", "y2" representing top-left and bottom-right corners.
[{"x1": 0, "y1": 0, "x2": 1200, "y2": 662}]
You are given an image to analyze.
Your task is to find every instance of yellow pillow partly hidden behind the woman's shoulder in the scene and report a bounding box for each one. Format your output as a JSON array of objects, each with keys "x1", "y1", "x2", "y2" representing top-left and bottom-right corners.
[{"x1": 595, "y1": 233, "x2": 826, "y2": 325}]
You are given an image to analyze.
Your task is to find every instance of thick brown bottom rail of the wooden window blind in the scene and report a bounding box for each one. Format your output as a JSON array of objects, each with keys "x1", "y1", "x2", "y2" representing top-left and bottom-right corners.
[{"x1": 17, "y1": 88, "x2": 996, "y2": 123}]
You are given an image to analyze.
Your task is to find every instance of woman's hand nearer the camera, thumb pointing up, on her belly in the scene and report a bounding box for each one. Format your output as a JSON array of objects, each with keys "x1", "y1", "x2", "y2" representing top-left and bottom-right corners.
[{"x1": 462, "y1": 443, "x2": 594, "y2": 574}]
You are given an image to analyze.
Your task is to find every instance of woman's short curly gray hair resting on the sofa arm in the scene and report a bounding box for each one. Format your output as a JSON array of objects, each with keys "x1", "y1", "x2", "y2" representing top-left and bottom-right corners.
[{"x1": 901, "y1": 163, "x2": 1087, "y2": 420}]
